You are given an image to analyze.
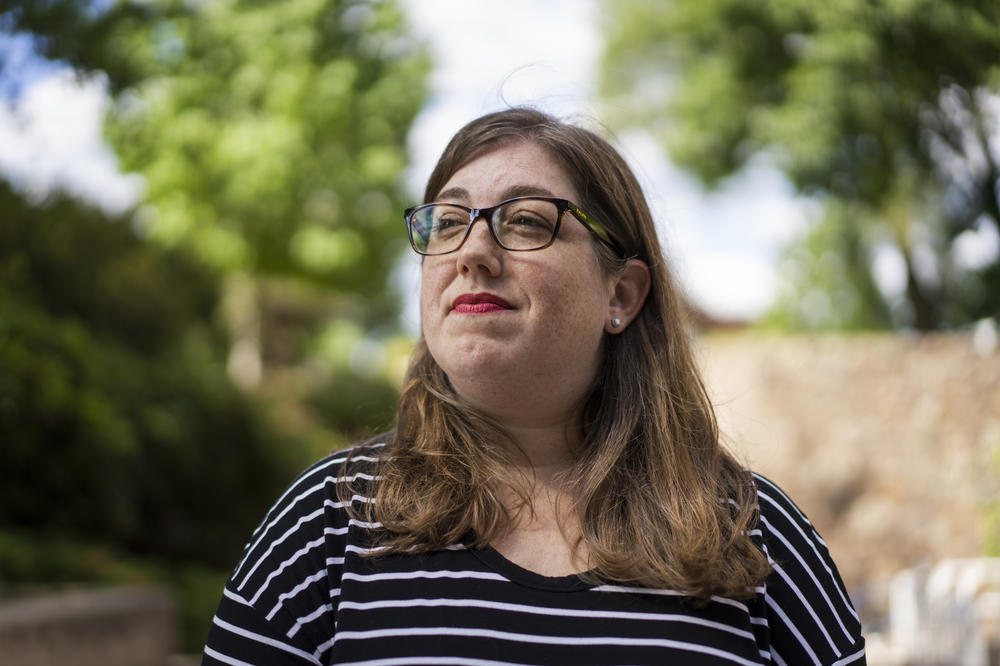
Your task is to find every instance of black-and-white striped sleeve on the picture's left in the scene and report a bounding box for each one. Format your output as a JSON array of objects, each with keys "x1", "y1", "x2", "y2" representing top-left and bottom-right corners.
[{"x1": 201, "y1": 444, "x2": 373, "y2": 666}]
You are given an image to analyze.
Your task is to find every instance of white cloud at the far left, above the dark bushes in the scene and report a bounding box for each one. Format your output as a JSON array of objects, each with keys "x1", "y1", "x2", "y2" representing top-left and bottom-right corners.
[{"x1": 0, "y1": 71, "x2": 142, "y2": 212}]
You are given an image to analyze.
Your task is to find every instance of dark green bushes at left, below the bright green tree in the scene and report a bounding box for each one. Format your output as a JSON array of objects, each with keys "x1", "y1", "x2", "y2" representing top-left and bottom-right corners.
[{"x1": 0, "y1": 183, "x2": 311, "y2": 566}]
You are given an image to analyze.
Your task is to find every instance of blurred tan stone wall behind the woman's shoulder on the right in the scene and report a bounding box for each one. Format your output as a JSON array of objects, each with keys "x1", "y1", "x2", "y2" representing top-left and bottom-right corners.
[{"x1": 699, "y1": 333, "x2": 1000, "y2": 615}]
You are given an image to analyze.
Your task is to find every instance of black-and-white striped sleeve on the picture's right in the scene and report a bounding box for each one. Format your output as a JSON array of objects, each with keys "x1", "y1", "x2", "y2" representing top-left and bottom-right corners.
[{"x1": 754, "y1": 475, "x2": 866, "y2": 666}]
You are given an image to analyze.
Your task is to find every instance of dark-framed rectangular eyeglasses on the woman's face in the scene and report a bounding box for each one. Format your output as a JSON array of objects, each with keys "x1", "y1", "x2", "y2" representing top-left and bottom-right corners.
[{"x1": 403, "y1": 197, "x2": 625, "y2": 256}]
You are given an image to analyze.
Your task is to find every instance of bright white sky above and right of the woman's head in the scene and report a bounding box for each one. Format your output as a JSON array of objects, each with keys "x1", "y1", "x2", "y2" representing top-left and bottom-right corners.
[{"x1": 403, "y1": 0, "x2": 817, "y2": 320}]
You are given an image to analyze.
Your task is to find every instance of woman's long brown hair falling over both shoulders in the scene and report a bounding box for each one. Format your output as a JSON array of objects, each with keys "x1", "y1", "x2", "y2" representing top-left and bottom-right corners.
[{"x1": 342, "y1": 108, "x2": 769, "y2": 599}]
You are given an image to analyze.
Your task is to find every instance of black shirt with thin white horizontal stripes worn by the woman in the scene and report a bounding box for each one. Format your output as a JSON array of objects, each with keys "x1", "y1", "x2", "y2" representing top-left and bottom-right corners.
[{"x1": 202, "y1": 444, "x2": 865, "y2": 666}]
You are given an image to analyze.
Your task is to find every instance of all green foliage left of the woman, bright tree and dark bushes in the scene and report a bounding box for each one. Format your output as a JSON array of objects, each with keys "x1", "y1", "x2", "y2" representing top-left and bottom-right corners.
[{"x1": 0, "y1": 0, "x2": 428, "y2": 651}]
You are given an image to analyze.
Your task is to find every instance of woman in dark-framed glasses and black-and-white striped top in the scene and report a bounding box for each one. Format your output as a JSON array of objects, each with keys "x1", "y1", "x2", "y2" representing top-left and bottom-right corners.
[{"x1": 203, "y1": 109, "x2": 864, "y2": 664}]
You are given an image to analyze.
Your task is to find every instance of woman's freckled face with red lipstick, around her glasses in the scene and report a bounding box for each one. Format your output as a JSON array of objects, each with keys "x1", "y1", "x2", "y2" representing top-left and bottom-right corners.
[{"x1": 421, "y1": 141, "x2": 614, "y2": 418}]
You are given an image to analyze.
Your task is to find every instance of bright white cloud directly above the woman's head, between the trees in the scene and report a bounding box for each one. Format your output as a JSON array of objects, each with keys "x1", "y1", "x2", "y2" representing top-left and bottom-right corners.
[{"x1": 402, "y1": 0, "x2": 601, "y2": 197}]
